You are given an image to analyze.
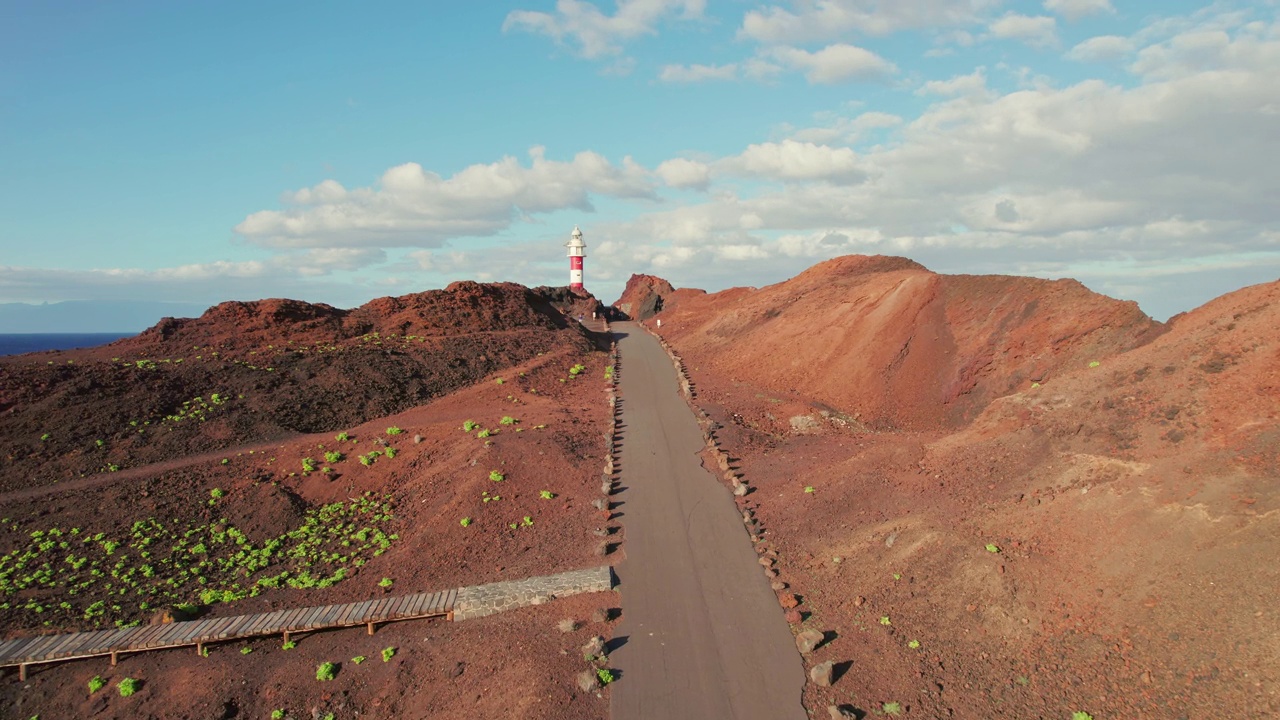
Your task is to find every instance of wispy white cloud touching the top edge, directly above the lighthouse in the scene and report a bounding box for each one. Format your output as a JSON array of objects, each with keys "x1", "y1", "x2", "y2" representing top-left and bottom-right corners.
[{"x1": 502, "y1": 0, "x2": 707, "y2": 59}]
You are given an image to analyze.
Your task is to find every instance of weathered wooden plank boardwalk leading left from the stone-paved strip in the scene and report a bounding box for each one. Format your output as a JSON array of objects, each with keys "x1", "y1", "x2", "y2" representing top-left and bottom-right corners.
[{"x1": 0, "y1": 589, "x2": 458, "y2": 680}]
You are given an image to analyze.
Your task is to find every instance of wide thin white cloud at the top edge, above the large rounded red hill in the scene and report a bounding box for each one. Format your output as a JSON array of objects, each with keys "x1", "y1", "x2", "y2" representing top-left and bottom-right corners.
[{"x1": 739, "y1": 0, "x2": 1000, "y2": 45}]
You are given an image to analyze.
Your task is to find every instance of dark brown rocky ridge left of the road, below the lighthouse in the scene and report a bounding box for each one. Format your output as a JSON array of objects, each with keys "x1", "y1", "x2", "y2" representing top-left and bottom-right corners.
[{"x1": 0, "y1": 282, "x2": 594, "y2": 489}]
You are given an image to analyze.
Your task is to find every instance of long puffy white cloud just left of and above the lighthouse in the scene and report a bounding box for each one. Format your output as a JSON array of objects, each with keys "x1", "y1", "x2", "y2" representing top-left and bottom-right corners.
[{"x1": 236, "y1": 147, "x2": 653, "y2": 247}]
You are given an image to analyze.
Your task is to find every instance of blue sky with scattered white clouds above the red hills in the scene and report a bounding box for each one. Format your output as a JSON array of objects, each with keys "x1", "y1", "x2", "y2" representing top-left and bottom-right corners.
[{"x1": 0, "y1": 0, "x2": 1280, "y2": 319}]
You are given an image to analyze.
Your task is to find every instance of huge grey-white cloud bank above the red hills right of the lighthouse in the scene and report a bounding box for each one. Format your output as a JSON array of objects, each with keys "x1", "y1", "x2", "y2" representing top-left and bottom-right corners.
[{"x1": 576, "y1": 12, "x2": 1280, "y2": 316}]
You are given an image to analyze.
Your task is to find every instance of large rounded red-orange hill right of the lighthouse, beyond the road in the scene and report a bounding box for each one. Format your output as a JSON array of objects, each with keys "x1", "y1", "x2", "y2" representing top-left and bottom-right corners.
[{"x1": 637, "y1": 256, "x2": 1165, "y2": 429}]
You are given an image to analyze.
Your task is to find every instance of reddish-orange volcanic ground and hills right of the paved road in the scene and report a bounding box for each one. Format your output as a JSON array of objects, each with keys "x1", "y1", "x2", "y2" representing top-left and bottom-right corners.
[{"x1": 632, "y1": 258, "x2": 1280, "y2": 719}]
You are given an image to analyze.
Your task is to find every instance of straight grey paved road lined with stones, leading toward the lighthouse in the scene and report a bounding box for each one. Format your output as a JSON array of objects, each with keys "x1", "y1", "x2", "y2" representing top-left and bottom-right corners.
[{"x1": 609, "y1": 323, "x2": 806, "y2": 720}]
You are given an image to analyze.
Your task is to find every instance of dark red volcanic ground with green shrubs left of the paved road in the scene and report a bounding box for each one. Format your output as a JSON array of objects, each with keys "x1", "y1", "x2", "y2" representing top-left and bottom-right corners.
[{"x1": 0, "y1": 283, "x2": 616, "y2": 719}]
